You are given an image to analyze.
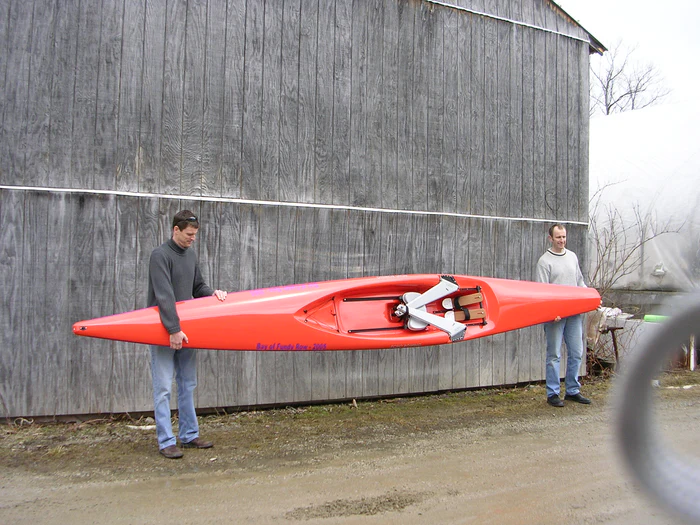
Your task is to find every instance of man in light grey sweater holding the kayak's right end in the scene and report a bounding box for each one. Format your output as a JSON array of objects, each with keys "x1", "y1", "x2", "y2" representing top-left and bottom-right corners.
[{"x1": 536, "y1": 224, "x2": 591, "y2": 407}]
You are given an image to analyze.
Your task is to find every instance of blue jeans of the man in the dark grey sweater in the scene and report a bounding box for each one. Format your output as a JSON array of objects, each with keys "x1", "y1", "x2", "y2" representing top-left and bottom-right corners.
[{"x1": 151, "y1": 346, "x2": 199, "y2": 449}]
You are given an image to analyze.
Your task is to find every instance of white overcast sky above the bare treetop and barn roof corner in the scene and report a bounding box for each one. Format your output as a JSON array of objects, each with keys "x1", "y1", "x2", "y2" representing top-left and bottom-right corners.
[{"x1": 555, "y1": 0, "x2": 700, "y2": 107}]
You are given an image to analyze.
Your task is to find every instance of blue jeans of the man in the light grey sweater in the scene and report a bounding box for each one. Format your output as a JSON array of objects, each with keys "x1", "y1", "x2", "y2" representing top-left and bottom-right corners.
[{"x1": 544, "y1": 315, "x2": 583, "y2": 397}]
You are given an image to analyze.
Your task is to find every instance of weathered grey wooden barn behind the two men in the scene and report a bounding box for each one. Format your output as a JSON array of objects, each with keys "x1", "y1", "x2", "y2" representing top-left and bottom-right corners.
[{"x1": 0, "y1": 0, "x2": 603, "y2": 418}]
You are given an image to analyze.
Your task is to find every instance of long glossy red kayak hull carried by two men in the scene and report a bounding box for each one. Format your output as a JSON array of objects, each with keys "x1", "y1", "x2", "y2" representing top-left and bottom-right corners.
[{"x1": 73, "y1": 274, "x2": 600, "y2": 351}]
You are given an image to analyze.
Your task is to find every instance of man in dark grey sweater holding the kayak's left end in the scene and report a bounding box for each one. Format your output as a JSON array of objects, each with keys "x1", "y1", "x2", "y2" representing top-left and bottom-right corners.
[{"x1": 148, "y1": 210, "x2": 226, "y2": 459}]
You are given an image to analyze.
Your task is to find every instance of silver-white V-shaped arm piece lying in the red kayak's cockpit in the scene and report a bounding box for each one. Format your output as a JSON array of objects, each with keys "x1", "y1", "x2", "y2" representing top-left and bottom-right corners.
[{"x1": 394, "y1": 275, "x2": 467, "y2": 343}]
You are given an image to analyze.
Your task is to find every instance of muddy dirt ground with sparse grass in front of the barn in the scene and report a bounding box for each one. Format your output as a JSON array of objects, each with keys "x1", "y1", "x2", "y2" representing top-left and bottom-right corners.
[{"x1": 0, "y1": 372, "x2": 700, "y2": 525}]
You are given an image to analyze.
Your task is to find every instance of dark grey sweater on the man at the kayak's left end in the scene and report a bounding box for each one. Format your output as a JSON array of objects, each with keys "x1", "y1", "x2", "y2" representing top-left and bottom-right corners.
[{"x1": 148, "y1": 239, "x2": 214, "y2": 334}]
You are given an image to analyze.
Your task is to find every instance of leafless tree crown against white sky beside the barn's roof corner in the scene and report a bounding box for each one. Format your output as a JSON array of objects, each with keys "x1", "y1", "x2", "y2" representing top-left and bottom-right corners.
[{"x1": 590, "y1": 42, "x2": 670, "y2": 115}]
